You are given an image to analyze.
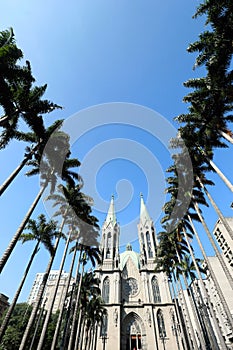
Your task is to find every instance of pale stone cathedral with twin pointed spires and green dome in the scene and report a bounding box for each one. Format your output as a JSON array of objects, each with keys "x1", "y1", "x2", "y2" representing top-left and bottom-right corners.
[{"x1": 96, "y1": 195, "x2": 184, "y2": 350}]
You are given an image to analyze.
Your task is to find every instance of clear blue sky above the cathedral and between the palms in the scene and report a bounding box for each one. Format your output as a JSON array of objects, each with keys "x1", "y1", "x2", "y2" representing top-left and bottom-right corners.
[{"x1": 0, "y1": 0, "x2": 233, "y2": 301}]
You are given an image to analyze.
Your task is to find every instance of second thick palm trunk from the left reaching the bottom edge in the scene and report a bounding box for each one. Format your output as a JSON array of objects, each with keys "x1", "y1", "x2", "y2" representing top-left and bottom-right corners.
[{"x1": 37, "y1": 229, "x2": 72, "y2": 350}]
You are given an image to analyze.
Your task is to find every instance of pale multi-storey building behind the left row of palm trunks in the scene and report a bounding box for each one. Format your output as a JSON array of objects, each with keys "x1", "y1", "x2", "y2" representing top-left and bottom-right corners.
[{"x1": 28, "y1": 270, "x2": 74, "y2": 313}]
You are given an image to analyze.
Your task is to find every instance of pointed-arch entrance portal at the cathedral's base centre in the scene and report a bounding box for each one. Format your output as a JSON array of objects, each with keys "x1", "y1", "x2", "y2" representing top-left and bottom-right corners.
[{"x1": 121, "y1": 312, "x2": 147, "y2": 350}]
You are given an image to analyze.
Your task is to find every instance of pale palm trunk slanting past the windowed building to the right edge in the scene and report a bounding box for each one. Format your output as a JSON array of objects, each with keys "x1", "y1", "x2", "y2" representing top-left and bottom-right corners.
[{"x1": 194, "y1": 202, "x2": 233, "y2": 289}]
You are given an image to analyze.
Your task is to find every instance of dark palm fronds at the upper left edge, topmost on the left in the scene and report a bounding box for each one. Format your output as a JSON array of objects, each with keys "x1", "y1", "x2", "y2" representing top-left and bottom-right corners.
[{"x1": 0, "y1": 29, "x2": 61, "y2": 148}]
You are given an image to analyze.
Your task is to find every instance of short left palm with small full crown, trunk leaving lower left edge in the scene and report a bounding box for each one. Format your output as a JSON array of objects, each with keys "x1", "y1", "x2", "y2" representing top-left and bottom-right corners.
[{"x1": 0, "y1": 214, "x2": 57, "y2": 341}]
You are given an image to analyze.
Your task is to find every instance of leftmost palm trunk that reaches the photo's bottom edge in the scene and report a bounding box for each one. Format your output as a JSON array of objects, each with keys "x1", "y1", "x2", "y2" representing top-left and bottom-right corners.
[{"x1": 19, "y1": 219, "x2": 65, "y2": 350}]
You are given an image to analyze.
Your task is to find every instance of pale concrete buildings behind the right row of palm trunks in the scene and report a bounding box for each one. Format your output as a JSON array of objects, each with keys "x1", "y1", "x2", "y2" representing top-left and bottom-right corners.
[{"x1": 179, "y1": 218, "x2": 233, "y2": 349}]
